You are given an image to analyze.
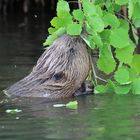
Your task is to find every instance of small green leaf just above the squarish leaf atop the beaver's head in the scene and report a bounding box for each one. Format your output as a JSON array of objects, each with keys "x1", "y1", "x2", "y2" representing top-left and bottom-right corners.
[{"x1": 73, "y1": 9, "x2": 84, "y2": 22}]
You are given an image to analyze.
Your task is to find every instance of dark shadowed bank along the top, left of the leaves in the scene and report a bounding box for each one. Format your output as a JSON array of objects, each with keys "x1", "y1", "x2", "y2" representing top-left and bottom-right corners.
[{"x1": 0, "y1": 0, "x2": 77, "y2": 15}]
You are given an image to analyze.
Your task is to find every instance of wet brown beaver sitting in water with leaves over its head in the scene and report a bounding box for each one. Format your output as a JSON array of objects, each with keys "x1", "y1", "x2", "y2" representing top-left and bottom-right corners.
[{"x1": 4, "y1": 35, "x2": 91, "y2": 99}]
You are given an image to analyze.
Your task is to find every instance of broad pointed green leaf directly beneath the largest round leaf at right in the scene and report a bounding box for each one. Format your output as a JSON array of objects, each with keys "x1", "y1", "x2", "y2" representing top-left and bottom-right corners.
[{"x1": 115, "y1": 42, "x2": 135, "y2": 65}]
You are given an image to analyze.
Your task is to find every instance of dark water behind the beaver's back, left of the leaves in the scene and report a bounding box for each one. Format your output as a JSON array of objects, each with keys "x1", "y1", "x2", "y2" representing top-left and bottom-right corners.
[{"x1": 0, "y1": 14, "x2": 50, "y2": 89}]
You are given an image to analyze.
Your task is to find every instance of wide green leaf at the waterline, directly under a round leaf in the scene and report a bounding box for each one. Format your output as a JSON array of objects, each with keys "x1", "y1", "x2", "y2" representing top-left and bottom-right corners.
[{"x1": 114, "y1": 84, "x2": 131, "y2": 94}]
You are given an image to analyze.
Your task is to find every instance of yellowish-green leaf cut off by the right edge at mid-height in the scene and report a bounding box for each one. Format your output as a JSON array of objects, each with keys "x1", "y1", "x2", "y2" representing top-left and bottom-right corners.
[{"x1": 131, "y1": 54, "x2": 140, "y2": 73}]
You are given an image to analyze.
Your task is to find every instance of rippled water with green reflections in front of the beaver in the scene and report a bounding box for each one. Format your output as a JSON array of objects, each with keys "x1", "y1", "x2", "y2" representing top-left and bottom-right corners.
[{"x1": 0, "y1": 95, "x2": 140, "y2": 140}]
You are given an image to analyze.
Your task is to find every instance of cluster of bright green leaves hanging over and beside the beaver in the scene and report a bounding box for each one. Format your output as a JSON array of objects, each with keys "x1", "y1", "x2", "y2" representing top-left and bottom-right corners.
[{"x1": 44, "y1": 0, "x2": 140, "y2": 94}]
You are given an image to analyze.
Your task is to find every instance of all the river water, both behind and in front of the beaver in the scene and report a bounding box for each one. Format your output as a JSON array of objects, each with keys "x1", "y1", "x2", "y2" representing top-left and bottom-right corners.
[{"x1": 0, "y1": 15, "x2": 140, "y2": 140}]
